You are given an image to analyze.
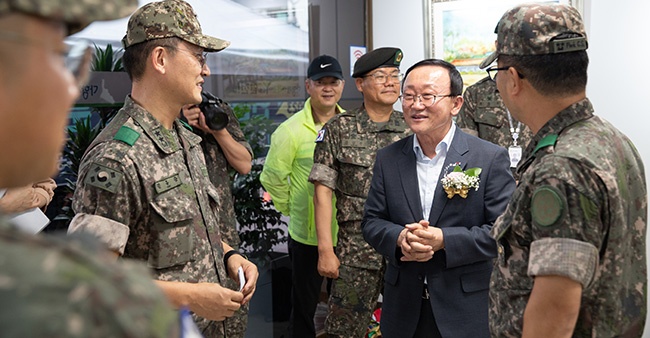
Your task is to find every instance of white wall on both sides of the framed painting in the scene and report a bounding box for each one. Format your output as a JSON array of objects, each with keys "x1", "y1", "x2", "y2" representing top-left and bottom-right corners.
[{"x1": 372, "y1": 0, "x2": 650, "y2": 338}]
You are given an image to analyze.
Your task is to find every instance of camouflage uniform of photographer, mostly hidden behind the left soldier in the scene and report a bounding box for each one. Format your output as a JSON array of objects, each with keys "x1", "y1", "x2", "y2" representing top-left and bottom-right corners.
[{"x1": 194, "y1": 100, "x2": 253, "y2": 338}]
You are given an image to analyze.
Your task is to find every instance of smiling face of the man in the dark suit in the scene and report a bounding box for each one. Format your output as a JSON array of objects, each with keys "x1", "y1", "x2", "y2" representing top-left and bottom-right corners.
[{"x1": 402, "y1": 65, "x2": 463, "y2": 141}]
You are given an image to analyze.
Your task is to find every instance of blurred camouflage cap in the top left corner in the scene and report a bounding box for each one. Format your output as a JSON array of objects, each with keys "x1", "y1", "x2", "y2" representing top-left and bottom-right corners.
[{"x1": 0, "y1": 0, "x2": 138, "y2": 34}]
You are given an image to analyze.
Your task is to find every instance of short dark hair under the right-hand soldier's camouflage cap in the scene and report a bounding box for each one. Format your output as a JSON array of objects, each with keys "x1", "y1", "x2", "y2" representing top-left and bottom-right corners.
[{"x1": 499, "y1": 50, "x2": 589, "y2": 96}]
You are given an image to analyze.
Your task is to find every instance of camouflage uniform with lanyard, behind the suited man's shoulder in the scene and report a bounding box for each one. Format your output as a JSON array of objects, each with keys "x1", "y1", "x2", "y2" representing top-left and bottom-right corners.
[{"x1": 456, "y1": 77, "x2": 532, "y2": 180}]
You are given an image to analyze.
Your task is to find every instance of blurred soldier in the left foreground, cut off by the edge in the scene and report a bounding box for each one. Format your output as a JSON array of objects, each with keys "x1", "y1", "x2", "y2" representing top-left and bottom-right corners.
[{"x1": 0, "y1": 0, "x2": 180, "y2": 338}]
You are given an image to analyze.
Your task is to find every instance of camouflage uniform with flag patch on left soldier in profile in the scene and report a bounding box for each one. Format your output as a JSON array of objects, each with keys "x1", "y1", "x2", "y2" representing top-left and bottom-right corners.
[{"x1": 70, "y1": 97, "x2": 226, "y2": 337}]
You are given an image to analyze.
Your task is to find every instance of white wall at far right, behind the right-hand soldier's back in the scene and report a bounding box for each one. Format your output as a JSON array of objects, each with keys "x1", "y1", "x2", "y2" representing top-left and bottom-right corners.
[{"x1": 585, "y1": 0, "x2": 650, "y2": 338}]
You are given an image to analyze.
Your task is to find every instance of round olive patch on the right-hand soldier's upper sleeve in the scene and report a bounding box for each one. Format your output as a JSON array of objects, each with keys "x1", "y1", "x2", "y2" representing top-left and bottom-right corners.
[{"x1": 530, "y1": 186, "x2": 565, "y2": 227}]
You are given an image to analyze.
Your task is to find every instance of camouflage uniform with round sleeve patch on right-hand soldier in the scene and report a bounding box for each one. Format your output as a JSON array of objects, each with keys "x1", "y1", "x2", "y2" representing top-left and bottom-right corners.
[{"x1": 490, "y1": 99, "x2": 648, "y2": 337}]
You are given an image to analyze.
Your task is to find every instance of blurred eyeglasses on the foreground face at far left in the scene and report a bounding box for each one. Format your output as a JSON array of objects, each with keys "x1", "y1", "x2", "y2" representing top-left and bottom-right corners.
[{"x1": 0, "y1": 31, "x2": 92, "y2": 88}]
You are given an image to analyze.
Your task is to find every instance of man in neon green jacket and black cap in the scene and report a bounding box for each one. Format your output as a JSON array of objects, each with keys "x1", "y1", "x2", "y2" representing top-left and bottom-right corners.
[{"x1": 260, "y1": 55, "x2": 345, "y2": 337}]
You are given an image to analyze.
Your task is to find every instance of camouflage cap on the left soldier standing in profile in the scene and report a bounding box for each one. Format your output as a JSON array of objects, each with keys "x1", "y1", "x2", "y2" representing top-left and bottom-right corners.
[{"x1": 122, "y1": 0, "x2": 230, "y2": 52}]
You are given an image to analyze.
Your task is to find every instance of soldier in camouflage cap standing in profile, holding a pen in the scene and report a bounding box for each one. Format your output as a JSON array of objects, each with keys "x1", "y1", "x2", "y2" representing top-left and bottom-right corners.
[{"x1": 69, "y1": 1, "x2": 258, "y2": 337}]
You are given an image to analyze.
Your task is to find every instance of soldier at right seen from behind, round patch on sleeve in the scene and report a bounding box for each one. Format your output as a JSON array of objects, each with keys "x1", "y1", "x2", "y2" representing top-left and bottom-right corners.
[{"x1": 488, "y1": 4, "x2": 648, "y2": 337}]
